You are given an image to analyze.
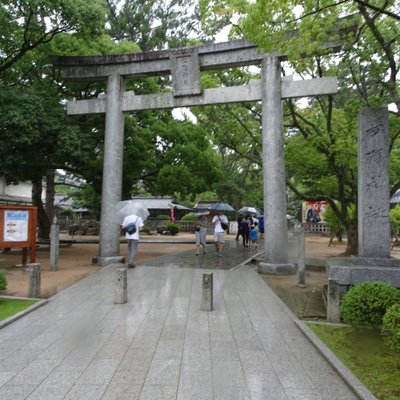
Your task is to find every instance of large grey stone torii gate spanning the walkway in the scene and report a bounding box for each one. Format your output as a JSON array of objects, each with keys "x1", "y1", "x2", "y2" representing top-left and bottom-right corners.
[{"x1": 53, "y1": 40, "x2": 337, "y2": 273}]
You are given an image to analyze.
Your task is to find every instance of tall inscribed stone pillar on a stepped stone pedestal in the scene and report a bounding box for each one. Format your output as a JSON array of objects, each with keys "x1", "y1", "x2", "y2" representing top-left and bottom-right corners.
[{"x1": 327, "y1": 108, "x2": 400, "y2": 322}]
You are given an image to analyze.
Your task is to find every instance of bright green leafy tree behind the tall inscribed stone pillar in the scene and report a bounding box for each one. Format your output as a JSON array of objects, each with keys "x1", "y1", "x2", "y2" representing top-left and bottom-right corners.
[{"x1": 206, "y1": 0, "x2": 400, "y2": 254}]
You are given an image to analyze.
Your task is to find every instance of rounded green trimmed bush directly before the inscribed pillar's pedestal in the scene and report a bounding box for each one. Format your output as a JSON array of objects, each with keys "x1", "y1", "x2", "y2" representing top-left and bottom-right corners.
[{"x1": 340, "y1": 282, "x2": 400, "y2": 328}]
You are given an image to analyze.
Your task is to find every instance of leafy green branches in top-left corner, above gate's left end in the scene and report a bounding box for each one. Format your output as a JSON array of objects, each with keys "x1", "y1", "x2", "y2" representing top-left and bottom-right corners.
[{"x1": 0, "y1": 0, "x2": 106, "y2": 80}]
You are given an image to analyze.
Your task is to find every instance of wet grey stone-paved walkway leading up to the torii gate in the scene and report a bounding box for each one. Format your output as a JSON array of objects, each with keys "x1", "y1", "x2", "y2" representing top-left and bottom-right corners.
[{"x1": 0, "y1": 242, "x2": 358, "y2": 400}]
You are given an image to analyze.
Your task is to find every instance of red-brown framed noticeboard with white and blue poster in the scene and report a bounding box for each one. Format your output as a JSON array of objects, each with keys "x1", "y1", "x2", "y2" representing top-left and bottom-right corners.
[{"x1": 0, "y1": 205, "x2": 37, "y2": 263}]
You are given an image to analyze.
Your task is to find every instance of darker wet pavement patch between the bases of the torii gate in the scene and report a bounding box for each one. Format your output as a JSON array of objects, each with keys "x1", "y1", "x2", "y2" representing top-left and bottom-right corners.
[{"x1": 138, "y1": 240, "x2": 260, "y2": 270}]
